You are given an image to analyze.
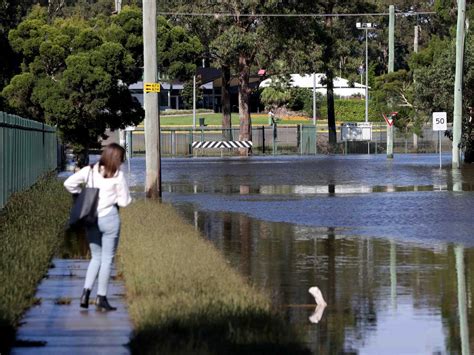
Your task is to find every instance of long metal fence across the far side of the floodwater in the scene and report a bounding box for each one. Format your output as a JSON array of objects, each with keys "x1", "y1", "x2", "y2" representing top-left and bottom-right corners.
[{"x1": 122, "y1": 123, "x2": 451, "y2": 157}]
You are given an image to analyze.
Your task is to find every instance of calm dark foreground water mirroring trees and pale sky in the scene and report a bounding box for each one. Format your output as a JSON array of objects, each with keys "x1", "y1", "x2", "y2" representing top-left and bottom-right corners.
[{"x1": 173, "y1": 204, "x2": 474, "y2": 354}]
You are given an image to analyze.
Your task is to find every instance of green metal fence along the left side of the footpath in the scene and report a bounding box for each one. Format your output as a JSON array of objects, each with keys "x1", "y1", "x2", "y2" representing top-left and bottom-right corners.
[{"x1": 0, "y1": 112, "x2": 58, "y2": 208}]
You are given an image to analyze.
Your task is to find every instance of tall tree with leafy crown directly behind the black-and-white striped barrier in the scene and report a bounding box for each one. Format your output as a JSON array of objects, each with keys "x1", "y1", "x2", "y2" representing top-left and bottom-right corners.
[{"x1": 160, "y1": 0, "x2": 288, "y2": 153}]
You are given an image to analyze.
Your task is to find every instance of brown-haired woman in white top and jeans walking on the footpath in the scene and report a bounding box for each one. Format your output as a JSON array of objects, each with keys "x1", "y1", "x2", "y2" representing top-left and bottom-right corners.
[{"x1": 64, "y1": 143, "x2": 131, "y2": 311}]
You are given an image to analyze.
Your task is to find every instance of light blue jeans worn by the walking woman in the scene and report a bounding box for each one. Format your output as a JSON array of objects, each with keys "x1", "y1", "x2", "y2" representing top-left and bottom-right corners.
[{"x1": 84, "y1": 207, "x2": 120, "y2": 296}]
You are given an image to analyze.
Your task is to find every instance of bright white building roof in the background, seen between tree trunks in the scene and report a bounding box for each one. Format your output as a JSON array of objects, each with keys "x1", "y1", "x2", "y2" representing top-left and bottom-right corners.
[{"x1": 260, "y1": 73, "x2": 370, "y2": 97}]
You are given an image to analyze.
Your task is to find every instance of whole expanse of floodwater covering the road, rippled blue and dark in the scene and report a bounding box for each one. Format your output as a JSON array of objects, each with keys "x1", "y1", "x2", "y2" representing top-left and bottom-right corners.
[{"x1": 129, "y1": 155, "x2": 474, "y2": 355}]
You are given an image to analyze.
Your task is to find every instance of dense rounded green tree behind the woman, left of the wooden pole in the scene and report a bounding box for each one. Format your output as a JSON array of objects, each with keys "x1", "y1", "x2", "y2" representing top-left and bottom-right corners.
[{"x1": 2, "y1": 9, "x2": 143, "y2": 160}]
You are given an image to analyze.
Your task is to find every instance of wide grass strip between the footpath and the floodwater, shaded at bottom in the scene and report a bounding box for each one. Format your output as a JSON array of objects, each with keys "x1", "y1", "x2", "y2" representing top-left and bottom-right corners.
[{"x1": 118, "y1": 201, "x2": 309, "y2": 354}]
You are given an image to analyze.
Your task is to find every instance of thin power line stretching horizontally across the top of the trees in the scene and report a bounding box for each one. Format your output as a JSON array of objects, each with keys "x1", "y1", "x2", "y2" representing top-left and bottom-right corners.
[{"x1": 158, "y1": 11, "x2": 436, "y2": 17}]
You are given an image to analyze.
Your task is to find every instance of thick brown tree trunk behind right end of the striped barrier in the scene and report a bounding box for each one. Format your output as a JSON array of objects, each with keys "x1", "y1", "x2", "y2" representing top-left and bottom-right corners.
[{"x1": 239, "y1": 55, "x2": 252, "y2": 155}]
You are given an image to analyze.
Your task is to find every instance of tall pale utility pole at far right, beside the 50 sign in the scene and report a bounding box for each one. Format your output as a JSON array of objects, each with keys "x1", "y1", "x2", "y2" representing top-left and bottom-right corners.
[{"x1": 452, "y1": 0, "x2": 466, "y2": 169}]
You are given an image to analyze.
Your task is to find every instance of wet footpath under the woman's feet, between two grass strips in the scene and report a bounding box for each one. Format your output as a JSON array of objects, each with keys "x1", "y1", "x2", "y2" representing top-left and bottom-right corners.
[{"x1": 12, "y1": 259, "x2": 132, "y2": 355}]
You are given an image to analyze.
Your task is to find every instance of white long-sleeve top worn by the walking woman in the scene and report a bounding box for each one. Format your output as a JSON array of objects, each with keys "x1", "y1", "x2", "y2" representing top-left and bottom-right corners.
[{"x1": 64, "y1": 164, "x2": 132, "y2": 217}]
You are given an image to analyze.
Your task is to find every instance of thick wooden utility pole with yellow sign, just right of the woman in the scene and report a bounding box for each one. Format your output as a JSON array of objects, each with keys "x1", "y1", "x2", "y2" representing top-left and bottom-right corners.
[{"x1": 143, "y1": 0, "x2": 161, "y2": 198}]
